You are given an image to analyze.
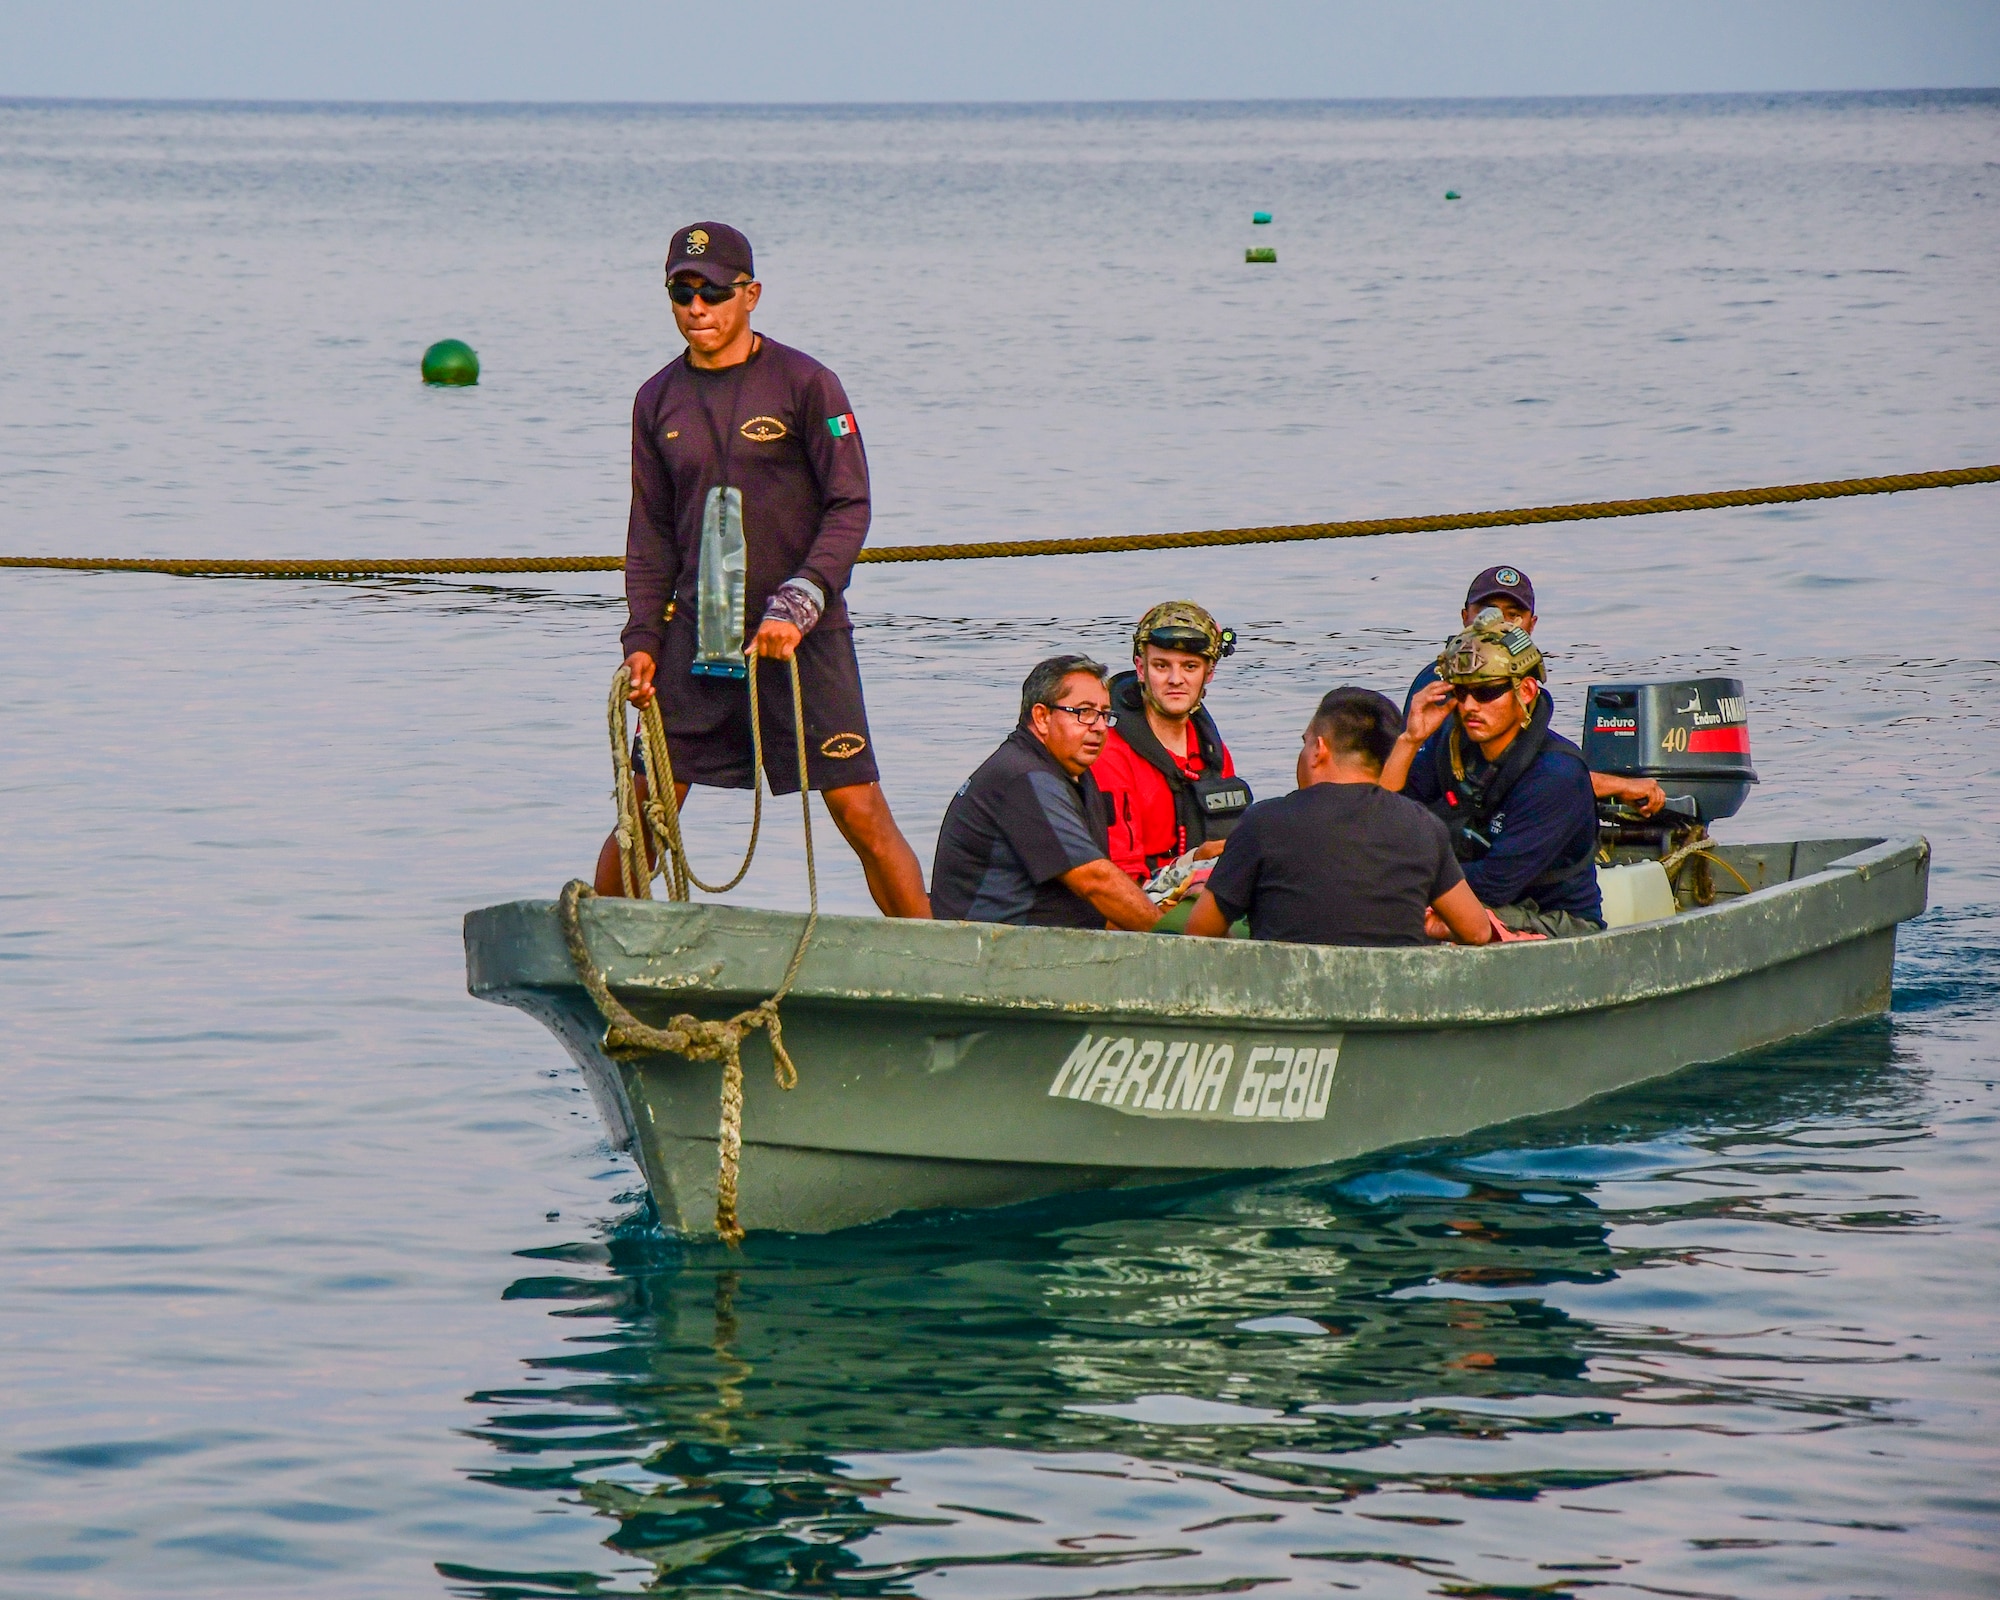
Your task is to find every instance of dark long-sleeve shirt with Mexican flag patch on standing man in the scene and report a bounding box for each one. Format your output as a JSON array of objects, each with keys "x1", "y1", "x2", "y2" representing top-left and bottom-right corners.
[{"x1": 620, "y1": 338, "x2": 868, "y2": 660}]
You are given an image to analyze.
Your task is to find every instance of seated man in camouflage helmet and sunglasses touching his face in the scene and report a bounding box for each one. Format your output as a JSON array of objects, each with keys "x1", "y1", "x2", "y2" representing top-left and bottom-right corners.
[{"x1": 1382, "y1": 620, "x2": 1604, "y2": 938}]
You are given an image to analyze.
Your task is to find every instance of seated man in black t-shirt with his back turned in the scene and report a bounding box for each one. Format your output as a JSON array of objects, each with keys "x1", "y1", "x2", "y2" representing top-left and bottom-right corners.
[{"x1": 1188, "y1": 688, "x2": 1494, "y2": 946}]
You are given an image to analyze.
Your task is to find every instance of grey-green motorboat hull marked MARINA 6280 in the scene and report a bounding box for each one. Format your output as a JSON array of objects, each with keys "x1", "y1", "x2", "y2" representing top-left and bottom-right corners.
[{"x1": 466, "y1": 836, "x2": 1930, "y2": 1236}]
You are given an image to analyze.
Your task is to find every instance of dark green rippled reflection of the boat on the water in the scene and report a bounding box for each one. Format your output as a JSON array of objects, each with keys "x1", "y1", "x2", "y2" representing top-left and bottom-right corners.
[{"x1": 448, "y1": 1022, "x2": 1924, "y2": 1600}]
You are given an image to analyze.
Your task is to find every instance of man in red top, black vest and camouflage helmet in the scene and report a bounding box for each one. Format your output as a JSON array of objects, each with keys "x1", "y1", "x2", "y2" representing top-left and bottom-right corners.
[{"x1": 1090, "y1": 600, "x2": 1250, "y2": 884}]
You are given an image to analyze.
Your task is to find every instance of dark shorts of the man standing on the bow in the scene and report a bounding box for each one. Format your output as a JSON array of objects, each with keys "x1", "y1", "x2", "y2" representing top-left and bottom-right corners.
[{"x1": 634, "y1": 614, "x2": 882, "y2": 794}]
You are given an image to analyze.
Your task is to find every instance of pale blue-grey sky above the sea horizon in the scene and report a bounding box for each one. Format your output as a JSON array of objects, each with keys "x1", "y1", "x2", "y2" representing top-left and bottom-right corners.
[{"x1": 11, "y1": 0, "x2": 2000, "y2": 102}]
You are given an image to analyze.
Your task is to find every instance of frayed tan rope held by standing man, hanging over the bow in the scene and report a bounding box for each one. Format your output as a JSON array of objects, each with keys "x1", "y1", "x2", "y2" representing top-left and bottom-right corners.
[{"x1": 556, "y1": 656, "x2": 820, "y2": 1250}]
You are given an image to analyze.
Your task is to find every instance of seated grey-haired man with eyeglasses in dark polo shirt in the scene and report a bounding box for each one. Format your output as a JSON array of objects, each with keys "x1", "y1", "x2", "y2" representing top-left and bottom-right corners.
[{"x1": 930, "y1": 656, "x2": 1160, "y2": 932}]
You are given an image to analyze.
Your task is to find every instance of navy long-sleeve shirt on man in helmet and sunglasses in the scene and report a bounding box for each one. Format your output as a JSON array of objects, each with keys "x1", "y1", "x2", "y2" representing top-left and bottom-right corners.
[{"x1": 1402, "y1": 722, "x2": 1604, "y2": 922}]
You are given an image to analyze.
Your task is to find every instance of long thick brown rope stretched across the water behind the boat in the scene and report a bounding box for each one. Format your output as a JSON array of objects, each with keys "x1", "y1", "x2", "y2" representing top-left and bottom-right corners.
[{"x1": 0, "y1": 466, "x2": 2000, "y2": 578}]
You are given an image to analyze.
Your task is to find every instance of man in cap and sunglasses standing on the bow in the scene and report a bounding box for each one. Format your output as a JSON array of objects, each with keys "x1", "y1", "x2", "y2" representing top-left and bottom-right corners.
[{"x1": 596, "y1": 222, "x2": 930, "y2": 916}]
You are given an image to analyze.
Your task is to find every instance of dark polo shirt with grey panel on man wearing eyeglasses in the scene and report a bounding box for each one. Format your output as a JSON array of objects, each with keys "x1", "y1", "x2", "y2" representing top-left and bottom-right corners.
[{"x1": 930, "y1": 724, "x2": 1110, "y2": 928}]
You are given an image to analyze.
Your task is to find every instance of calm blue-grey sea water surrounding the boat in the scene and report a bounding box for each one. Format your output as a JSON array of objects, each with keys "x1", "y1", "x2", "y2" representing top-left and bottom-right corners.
[{"x1": 0, "y1": 94, "x2": 2000, "y2": 1600}]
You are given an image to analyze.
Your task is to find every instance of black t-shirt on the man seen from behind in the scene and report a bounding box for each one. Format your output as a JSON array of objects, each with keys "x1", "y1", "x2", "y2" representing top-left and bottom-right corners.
[{"x1": 1208, "y1": 784, "x2": 1466, "y2": 944}]
